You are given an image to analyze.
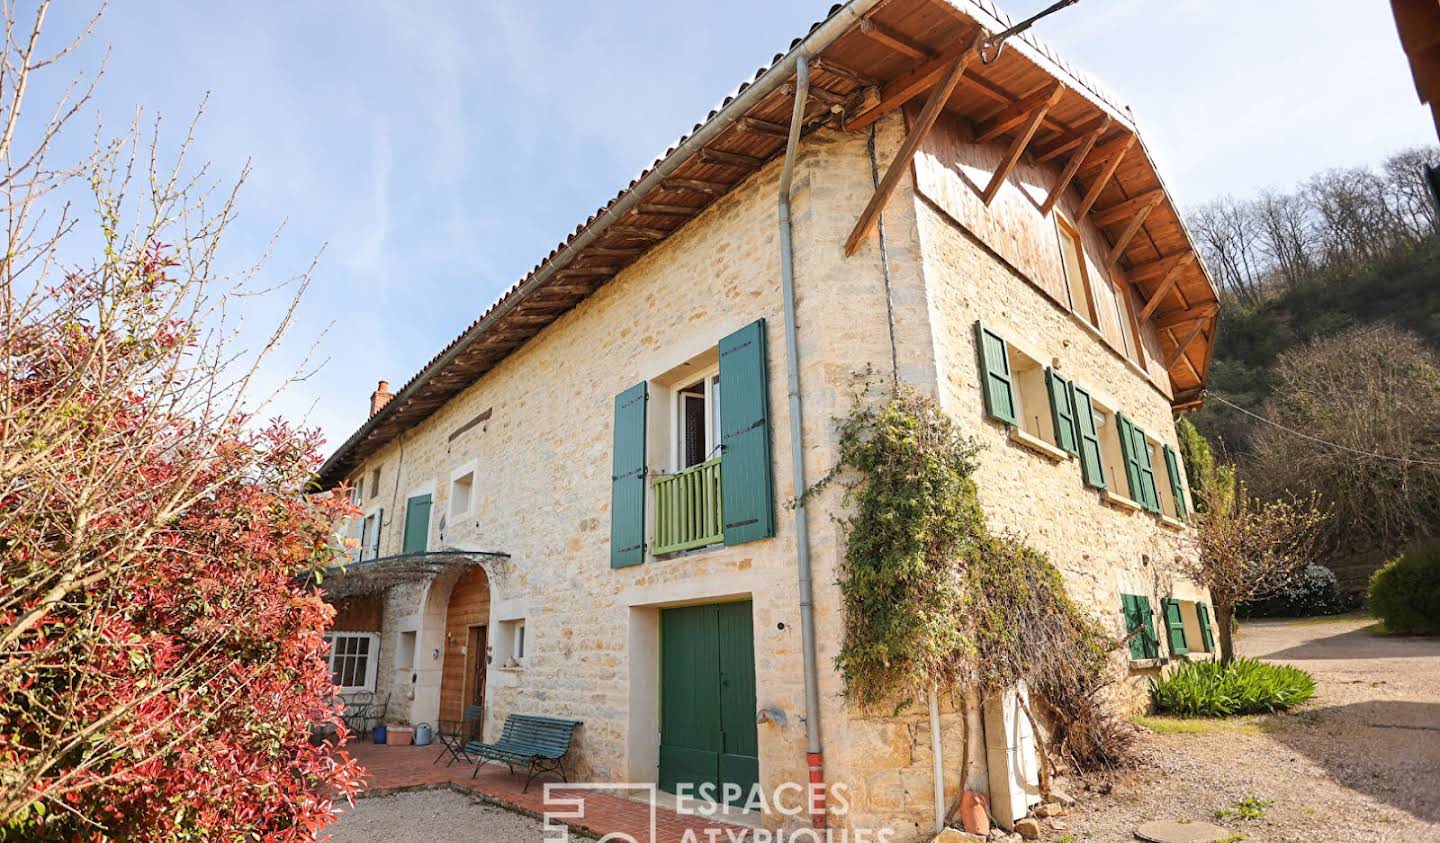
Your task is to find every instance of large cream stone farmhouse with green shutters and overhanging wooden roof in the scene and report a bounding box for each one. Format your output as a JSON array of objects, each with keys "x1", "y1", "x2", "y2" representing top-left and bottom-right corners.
[{"x1": 320, "y1": 0, "x2": 1218, "y2": 840}]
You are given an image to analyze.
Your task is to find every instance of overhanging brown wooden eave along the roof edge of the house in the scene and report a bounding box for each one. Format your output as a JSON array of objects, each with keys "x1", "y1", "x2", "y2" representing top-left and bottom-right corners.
[{"x1": 318, "y1": 0, "x2": 1217, "y2": 487}]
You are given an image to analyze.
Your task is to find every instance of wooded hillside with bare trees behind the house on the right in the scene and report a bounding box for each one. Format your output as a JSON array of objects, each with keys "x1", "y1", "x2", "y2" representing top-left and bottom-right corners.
[{"x1": 1189, "y1": 148, "x2": 1440, "y2": 591}]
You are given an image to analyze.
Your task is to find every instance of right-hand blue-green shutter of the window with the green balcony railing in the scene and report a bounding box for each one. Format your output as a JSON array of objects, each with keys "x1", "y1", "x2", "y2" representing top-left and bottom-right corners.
[{"x1": 720, "y1": 318, "x2": 775, "y2": 545}]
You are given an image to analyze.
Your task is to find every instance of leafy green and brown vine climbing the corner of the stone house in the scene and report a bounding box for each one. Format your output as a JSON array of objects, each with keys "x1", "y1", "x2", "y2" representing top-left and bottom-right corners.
[{"x1": 811, "y1": 388, "x2": 1123, "y2": 767}]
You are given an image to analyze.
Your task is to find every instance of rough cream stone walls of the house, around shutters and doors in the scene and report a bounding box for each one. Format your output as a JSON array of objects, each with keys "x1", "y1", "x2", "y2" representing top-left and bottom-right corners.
[{"x1": 329, "y1": 114, "x2": 1202, "y2": 840}]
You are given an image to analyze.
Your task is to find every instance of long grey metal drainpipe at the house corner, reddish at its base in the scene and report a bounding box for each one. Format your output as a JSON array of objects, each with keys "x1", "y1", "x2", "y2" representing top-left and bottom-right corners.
[{"x1": 780, "y1": 53, "x2": 825, "y2": 829}]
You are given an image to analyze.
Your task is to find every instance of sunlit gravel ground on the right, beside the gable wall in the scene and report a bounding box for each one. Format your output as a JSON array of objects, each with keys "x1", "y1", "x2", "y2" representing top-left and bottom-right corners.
[{"x1": 1048, "y1": 617, "x2": 1440, "y2": 843}]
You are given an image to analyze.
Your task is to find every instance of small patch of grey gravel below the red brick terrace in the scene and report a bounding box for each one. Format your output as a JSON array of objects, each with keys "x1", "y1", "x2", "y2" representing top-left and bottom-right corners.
[{"x1": 321, "y1": 790, "x2": 544, "y2": 843}]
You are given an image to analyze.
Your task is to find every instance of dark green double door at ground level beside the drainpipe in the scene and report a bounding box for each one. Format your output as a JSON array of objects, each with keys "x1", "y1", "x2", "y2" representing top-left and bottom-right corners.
[{"x1": 660, "y1": 601, "x2": 760, "y2": 803}]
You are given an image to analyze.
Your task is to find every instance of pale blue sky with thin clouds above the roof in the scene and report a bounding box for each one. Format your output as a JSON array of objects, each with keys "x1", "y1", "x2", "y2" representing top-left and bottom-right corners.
[{"x1": 37, "y1": 0, "x2": 1434, "y2": 448}]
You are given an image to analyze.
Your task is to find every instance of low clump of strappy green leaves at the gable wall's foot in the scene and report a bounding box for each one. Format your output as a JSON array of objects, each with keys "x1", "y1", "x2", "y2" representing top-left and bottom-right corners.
[{"x1": 1151, "y1": 659, "x2": 1315, "y2": 718}]
